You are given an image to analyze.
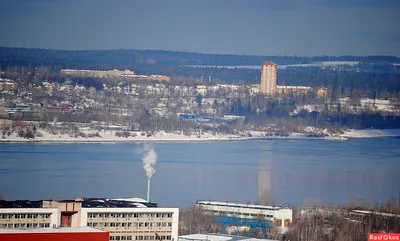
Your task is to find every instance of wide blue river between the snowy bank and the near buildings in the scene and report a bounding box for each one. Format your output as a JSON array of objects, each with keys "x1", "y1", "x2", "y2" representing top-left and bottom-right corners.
[{"x1": 0, "y1": 138, "x2": 400, "y2": 207}]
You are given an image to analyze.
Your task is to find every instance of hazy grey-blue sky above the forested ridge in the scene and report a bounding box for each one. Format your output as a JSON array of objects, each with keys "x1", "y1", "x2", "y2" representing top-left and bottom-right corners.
[{"x1": 0, "y1": 0, "x2": 400, "y2": 56}]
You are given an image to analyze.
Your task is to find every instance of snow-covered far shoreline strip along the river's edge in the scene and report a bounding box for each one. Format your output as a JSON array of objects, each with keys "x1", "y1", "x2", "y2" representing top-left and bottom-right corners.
[{"x1": 0, "y1": 129, "x2": 400, "y2": 144}]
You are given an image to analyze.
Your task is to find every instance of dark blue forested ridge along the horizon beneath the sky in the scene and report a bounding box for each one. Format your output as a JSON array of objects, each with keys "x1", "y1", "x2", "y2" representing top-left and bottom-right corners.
[{"x1": 0, "y1": 47, "x2": 400, "y2": 71}]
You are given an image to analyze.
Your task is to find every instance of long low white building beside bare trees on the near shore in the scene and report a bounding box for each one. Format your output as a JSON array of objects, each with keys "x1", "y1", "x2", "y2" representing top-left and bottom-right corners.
[{"x1": 196, "y1": 201, "x2": 293, "y2": 228}]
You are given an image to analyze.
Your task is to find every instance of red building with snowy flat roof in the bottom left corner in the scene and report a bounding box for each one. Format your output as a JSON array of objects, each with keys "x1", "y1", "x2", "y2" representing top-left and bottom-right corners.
[{"x1": 0, "y1": 227, "x2": 109, "y2": 241}]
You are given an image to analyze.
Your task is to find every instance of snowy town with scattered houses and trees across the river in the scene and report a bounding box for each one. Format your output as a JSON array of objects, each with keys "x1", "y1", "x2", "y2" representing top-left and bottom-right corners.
[{"x1": 0, "y1": 47, "x2": 400, "y2": 141}]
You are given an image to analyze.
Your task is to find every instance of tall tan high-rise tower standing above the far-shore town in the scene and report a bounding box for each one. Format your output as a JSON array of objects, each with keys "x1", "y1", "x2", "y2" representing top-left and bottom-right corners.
[{"x1": 260, "y1": 62, "x2": 278, "y2": 95}]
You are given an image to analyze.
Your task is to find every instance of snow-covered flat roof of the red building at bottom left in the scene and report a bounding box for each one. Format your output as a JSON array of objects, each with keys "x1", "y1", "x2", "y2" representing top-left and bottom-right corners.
[{"x1": 0, "y1": 227, "x2": 107, "y2": 234}]
